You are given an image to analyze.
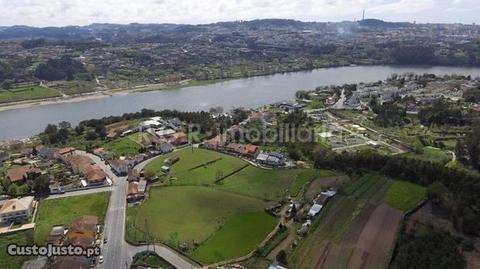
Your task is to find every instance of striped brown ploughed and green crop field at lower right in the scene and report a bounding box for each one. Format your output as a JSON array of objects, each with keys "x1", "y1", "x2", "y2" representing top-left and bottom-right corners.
[{"x1": 289, "y1": 174, "x2": 402, "y2": 269}]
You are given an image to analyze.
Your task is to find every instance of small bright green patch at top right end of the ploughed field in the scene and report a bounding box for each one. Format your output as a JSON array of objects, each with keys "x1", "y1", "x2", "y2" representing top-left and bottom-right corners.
[{"x1": 384, "y1": 181, "x2": 426, "y2": 211}]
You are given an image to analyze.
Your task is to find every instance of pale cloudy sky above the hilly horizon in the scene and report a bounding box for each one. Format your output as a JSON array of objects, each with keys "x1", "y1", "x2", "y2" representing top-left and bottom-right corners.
[{"x1": 0, "y1": 0, "x2": 480, "y2": 27}]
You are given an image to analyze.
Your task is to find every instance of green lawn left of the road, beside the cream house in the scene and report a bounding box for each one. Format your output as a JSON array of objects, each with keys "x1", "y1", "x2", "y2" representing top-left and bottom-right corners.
[{"x1": 35, "y1": 192, "x2": 110, "y2": 244}]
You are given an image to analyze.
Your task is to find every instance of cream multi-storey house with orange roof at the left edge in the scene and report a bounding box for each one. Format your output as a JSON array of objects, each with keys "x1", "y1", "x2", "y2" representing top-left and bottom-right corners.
[{"x1": 0, "y1": 196, "x2": 33, "y2": 224}]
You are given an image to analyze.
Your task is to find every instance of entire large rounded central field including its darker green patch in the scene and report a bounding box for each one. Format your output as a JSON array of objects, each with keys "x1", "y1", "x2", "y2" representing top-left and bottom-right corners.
[{"x1": 127, "y1": 186, "x2": 276, "y2": 263}]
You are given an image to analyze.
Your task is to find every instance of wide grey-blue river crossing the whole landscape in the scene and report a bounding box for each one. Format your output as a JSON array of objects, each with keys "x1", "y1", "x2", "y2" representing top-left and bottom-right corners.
[{"x1": 0, "y1": 66, "x2": 480, "y2": 140}]
